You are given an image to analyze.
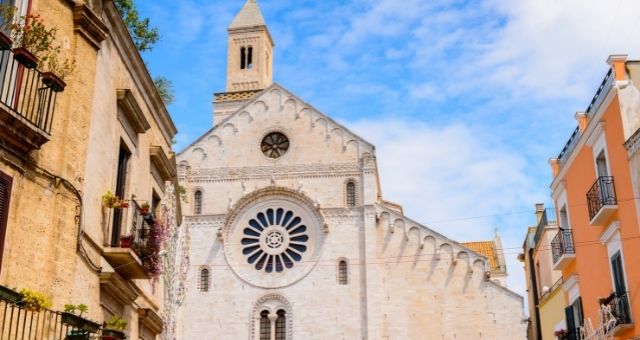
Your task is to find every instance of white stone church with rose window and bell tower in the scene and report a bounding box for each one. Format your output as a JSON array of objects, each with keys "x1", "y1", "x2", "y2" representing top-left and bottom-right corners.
[{"x1": 178, "y1": 0, "x2": 526, "y2": 340}]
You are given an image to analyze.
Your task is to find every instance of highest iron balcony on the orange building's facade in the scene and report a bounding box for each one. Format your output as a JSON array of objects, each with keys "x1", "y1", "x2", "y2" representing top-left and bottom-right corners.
[{"x1": 587, "y1": 176, "x2": 618, "y2": 225}]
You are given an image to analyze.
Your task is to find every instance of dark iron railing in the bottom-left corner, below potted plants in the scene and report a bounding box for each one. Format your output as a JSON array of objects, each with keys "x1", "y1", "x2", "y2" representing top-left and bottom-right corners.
[{"x1": 0, "y1": 287, "x2": 99, "y2": 340}]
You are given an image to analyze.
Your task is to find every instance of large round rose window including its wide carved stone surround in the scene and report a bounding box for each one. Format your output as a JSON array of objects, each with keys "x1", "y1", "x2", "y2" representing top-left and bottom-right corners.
[{"x1": 223, "y1": 187, "x2": 326, "y2": 288}]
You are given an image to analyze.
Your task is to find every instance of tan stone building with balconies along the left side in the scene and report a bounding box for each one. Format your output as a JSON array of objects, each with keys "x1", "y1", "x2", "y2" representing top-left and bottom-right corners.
[{"x1": 0, "y1": 0, "x2": 181, "y2": 339}]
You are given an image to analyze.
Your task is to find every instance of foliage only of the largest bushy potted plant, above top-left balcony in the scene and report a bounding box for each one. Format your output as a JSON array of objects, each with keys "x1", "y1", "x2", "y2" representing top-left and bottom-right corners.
[{"x1": 11, "y1": 14, "x2": 60, "y2": 62}]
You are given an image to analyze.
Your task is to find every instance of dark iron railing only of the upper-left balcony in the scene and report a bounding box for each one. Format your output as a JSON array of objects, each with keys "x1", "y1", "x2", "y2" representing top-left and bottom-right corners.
[{"x1": 0, "y1": 50, "x2": 56, "y2": 134}]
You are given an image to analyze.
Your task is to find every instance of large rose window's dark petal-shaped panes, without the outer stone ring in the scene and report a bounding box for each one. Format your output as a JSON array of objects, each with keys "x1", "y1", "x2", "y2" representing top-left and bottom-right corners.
[{"x1": 241, "y1": 208, "x2": 309, "y2": 273}]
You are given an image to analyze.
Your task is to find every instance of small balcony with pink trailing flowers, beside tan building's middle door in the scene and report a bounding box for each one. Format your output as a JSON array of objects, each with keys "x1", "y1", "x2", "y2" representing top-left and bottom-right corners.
[{"x1": 103, "y1": 200, "x2": 154, "y2": 279}]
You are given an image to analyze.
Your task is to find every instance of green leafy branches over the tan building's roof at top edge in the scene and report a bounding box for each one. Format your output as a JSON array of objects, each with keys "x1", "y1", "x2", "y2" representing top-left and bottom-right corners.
[{"x1": 113, "y1": 0, "x2": 160, "y2": 52}]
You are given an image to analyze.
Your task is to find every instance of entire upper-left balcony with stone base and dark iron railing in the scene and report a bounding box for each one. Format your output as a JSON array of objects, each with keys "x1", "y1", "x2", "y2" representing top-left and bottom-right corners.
[{"x1": 0, "y1": 50, "x2": 57, "y2": 153}]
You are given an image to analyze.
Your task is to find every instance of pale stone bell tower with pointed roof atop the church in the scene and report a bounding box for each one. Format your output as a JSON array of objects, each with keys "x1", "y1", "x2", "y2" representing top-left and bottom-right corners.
[{"x1": 213, "y1": 0, "x2": 274, "y2": 125}]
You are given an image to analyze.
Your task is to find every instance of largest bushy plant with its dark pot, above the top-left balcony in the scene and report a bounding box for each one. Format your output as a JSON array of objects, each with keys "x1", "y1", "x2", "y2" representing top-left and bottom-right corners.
[{"x1": 11, "y1": 14, "x2": 60, "y2": 68}]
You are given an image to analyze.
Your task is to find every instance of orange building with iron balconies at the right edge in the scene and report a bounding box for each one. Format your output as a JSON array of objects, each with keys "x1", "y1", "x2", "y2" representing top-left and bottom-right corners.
[{"x1": 550, "y1": 55, "x2": 640, "y2": 339}]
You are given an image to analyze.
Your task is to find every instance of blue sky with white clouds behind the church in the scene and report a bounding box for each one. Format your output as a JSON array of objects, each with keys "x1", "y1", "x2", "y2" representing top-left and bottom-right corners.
[{"x1": 137, "y1": 0, "x2": 640, "y2": 294}]
